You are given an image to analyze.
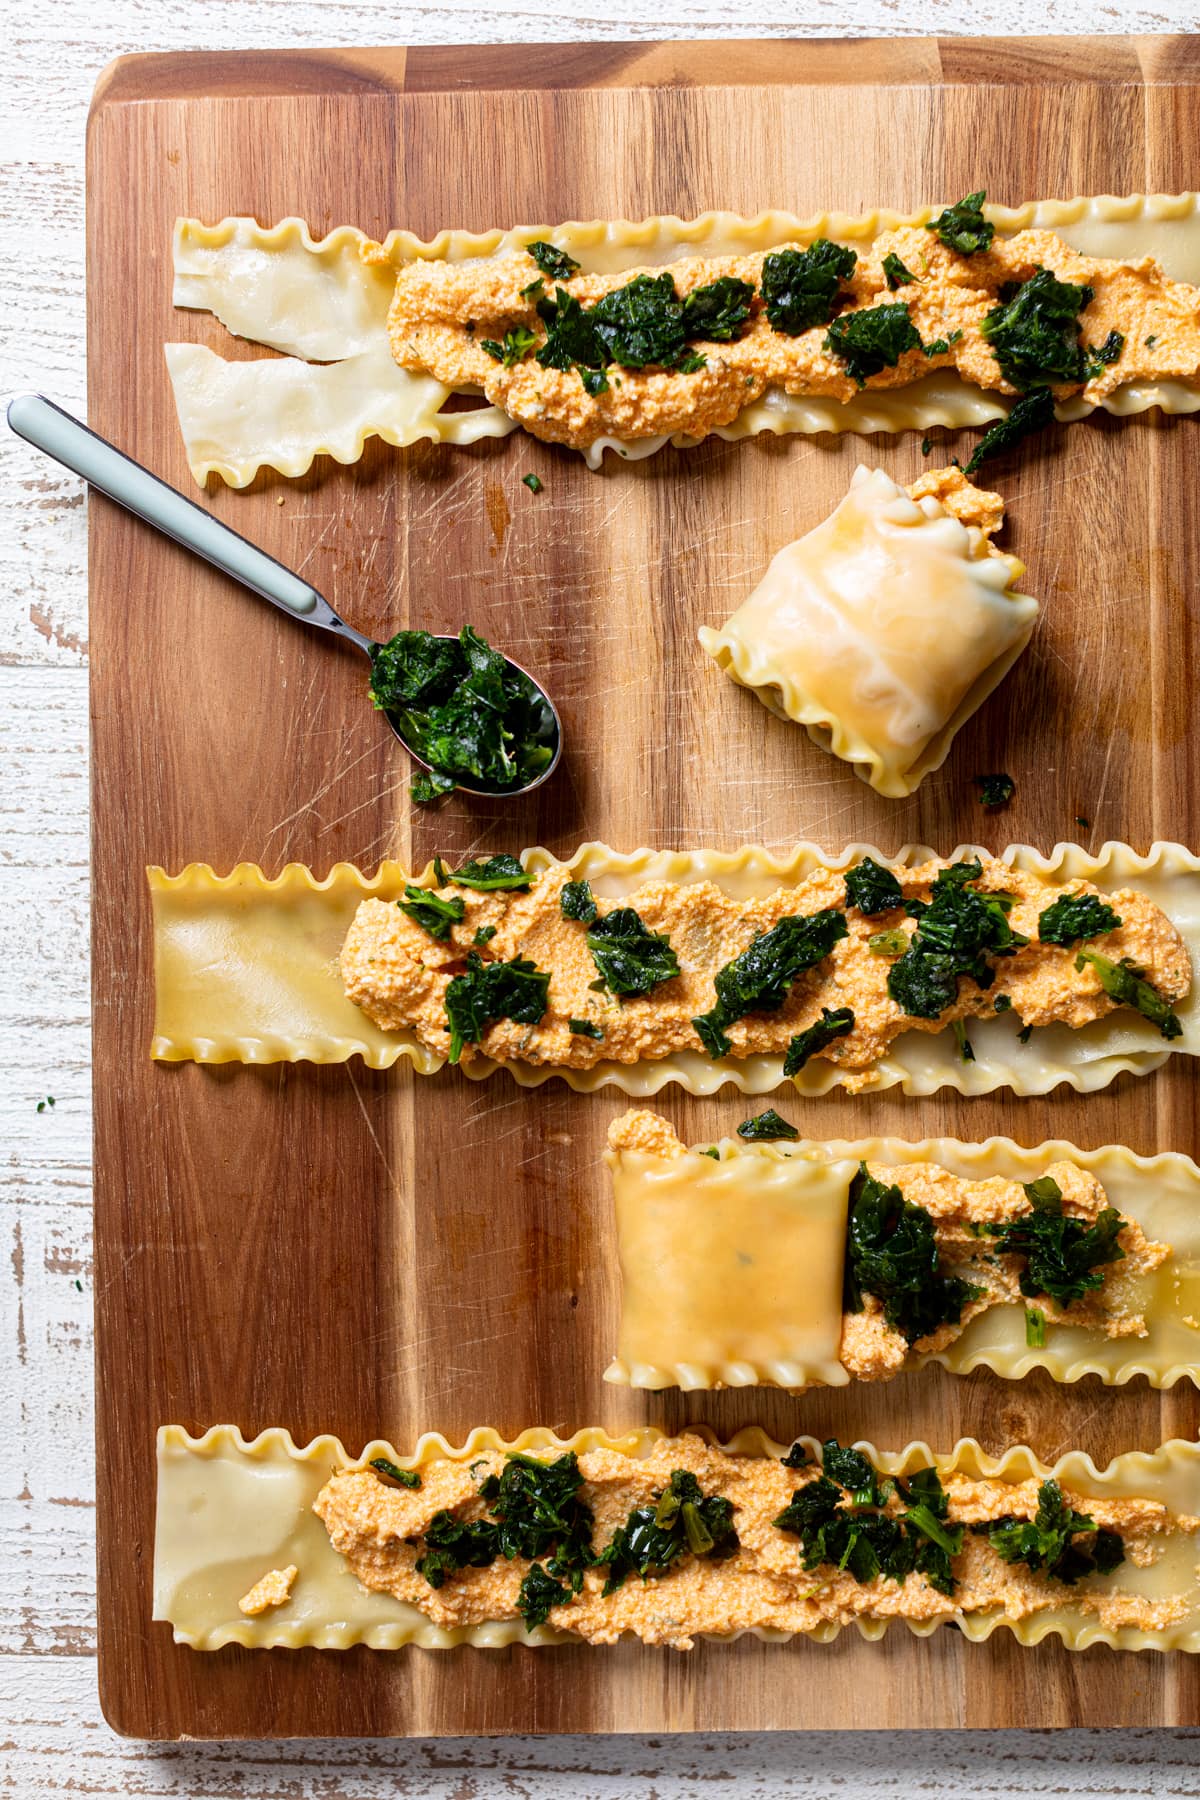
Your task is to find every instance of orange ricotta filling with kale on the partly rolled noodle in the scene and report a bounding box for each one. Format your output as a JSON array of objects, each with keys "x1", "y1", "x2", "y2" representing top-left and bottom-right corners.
[{"x1": 608, "y1": 1111, "x2": 1171, "y2": 1381}]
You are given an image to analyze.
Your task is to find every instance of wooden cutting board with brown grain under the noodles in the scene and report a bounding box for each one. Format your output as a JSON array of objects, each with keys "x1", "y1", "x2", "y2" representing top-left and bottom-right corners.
[{"x1": 88, "y1": 38, "x2": 1200, "y2": 1737}]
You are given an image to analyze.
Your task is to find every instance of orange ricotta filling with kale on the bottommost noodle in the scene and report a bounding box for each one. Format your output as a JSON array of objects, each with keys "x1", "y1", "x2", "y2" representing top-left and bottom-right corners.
[{"x1": 313, "y1": 1433, "x2": 1200, "y2": 1651}]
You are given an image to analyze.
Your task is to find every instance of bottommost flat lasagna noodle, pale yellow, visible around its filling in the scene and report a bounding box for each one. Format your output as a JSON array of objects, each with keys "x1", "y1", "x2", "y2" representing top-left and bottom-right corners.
[{"x1": 153, "y1": 1426, "x2": 1200, "y2": 1652}]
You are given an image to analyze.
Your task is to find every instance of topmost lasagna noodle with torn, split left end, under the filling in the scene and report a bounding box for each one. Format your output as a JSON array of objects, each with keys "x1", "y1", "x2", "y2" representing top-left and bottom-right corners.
[{"x1": 167, "y1": 193, "x2": 1200, "y2": 488}]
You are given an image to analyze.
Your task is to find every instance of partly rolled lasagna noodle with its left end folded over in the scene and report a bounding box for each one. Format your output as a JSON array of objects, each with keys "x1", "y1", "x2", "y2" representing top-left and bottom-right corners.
[{"x1": 604, "y1": 1138, "x2": 1200, "y2": 1390}]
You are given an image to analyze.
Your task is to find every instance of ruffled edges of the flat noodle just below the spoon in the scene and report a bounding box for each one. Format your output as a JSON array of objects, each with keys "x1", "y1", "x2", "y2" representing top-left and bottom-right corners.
[{"x1": 148, "y1": 841, "x2": 1200, "y2": 1100}]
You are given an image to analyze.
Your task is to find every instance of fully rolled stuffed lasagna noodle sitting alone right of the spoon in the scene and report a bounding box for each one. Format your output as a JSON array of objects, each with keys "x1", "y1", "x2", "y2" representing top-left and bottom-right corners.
[{"x1": 700, "y1": 466, "x2": 1038, "y2": 797}]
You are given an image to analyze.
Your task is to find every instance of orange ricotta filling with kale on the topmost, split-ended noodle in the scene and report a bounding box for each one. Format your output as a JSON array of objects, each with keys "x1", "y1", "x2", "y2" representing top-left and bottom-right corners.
[{"x1": 363, "y1": 194, "x2": 1200, "y2": 448}]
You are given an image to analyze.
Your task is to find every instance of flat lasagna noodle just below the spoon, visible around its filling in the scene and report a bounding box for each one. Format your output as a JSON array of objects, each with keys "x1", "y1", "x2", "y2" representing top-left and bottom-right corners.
[{"x1": 148, "y1": 844, "x2": 1200, "y2": 1098}]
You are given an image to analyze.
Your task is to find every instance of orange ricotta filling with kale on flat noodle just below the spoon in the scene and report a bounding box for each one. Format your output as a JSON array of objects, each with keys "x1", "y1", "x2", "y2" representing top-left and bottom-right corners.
[{"x1": 340, "y1": 855, "x2": 1191, "y2": 1091}]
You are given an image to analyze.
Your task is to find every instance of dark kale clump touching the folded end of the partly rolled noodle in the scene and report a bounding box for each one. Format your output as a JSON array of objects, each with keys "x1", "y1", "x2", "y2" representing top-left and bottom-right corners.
[{"x1": 842, "y1": 1163, "x2": 979, "y2": 1345}]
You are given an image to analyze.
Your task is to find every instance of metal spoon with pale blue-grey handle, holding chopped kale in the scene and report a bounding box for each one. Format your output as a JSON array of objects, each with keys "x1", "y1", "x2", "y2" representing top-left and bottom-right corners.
[{"x1": 9, "y1": 394, "x2": 563, "y2": 799}]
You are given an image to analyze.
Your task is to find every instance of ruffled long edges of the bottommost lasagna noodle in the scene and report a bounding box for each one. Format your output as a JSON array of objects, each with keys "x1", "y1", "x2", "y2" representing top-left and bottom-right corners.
[{"x1": 155, "y1": 1426, "x2": 1200, "y2": 1654}]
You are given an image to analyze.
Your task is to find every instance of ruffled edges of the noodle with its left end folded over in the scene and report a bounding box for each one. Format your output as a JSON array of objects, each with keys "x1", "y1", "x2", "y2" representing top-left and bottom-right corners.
[{"x1": 604, "y1": 1138, "x2": 1200, "y2": 1393}]
